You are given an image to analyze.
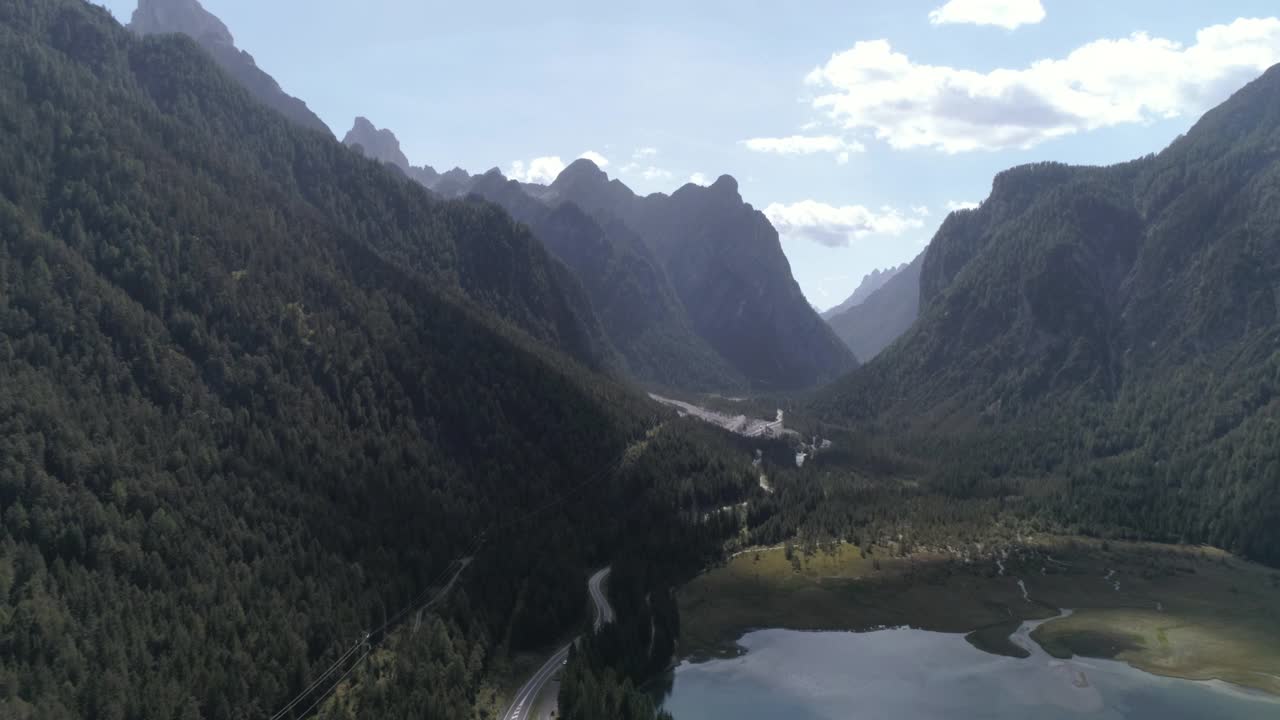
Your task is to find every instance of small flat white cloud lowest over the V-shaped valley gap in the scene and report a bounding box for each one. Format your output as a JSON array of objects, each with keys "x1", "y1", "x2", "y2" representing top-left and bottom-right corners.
[{"x1": 764, "y1": 200, "x2": 924, "y2": 247}]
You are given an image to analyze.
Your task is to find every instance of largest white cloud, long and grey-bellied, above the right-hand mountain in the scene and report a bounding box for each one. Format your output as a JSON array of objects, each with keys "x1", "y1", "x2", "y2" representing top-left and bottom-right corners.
[{"x1": 805, "y1": 18, "x2": 1280, "y2": 152}]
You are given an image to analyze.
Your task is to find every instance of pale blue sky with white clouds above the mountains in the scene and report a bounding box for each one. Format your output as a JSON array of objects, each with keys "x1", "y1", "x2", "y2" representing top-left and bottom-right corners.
[{"x1": 104, "y1": 0, "x2": 1280, "y2": 309}]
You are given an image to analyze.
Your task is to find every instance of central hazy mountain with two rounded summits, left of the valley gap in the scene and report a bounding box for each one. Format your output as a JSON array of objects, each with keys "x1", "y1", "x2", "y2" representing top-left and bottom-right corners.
[{"x1": 549, "y1": 159, "x2": 856, "y2": 389}]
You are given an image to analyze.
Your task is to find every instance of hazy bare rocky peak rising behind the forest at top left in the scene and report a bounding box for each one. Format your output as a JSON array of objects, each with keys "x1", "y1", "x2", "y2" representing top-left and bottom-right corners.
[{"x1": 129, "y1": 0, "x2": 333, "y2": 136}]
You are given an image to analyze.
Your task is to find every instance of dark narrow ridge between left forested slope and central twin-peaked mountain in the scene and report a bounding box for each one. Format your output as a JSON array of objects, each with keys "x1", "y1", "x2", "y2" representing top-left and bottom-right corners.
[{"x1": 468, "y1": 170, "x2": 745, "y2": 391}]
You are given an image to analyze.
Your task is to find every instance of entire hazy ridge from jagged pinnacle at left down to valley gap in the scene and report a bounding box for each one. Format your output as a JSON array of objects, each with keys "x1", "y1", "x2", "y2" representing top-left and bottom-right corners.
[{"x1": 344, "y1": 124, "x2": 856, "y2": 391}]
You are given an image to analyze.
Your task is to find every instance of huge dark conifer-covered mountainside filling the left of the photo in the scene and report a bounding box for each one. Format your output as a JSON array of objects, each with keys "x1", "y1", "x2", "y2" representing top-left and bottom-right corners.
[{"x1": 0, "y1": 0, "x2": 701, "y2": 719}]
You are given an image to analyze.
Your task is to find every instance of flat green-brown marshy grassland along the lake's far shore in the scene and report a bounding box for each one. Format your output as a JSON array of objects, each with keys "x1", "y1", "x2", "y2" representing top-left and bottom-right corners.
[{"x1": 678, "y1": 538, "x2": 1280, "y2": 700}]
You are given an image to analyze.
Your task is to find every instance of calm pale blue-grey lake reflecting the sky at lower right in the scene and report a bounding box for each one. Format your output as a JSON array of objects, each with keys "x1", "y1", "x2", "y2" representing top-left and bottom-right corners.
[{"x1": 663, "y1": 614, "x2": 1280, "y2": 720}]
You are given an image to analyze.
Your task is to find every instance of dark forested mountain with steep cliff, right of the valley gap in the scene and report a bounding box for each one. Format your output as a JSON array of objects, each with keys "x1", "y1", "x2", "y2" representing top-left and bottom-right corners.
[{"x1": 818, "y1": 67, "x2": 1280, "y2": 564}]
